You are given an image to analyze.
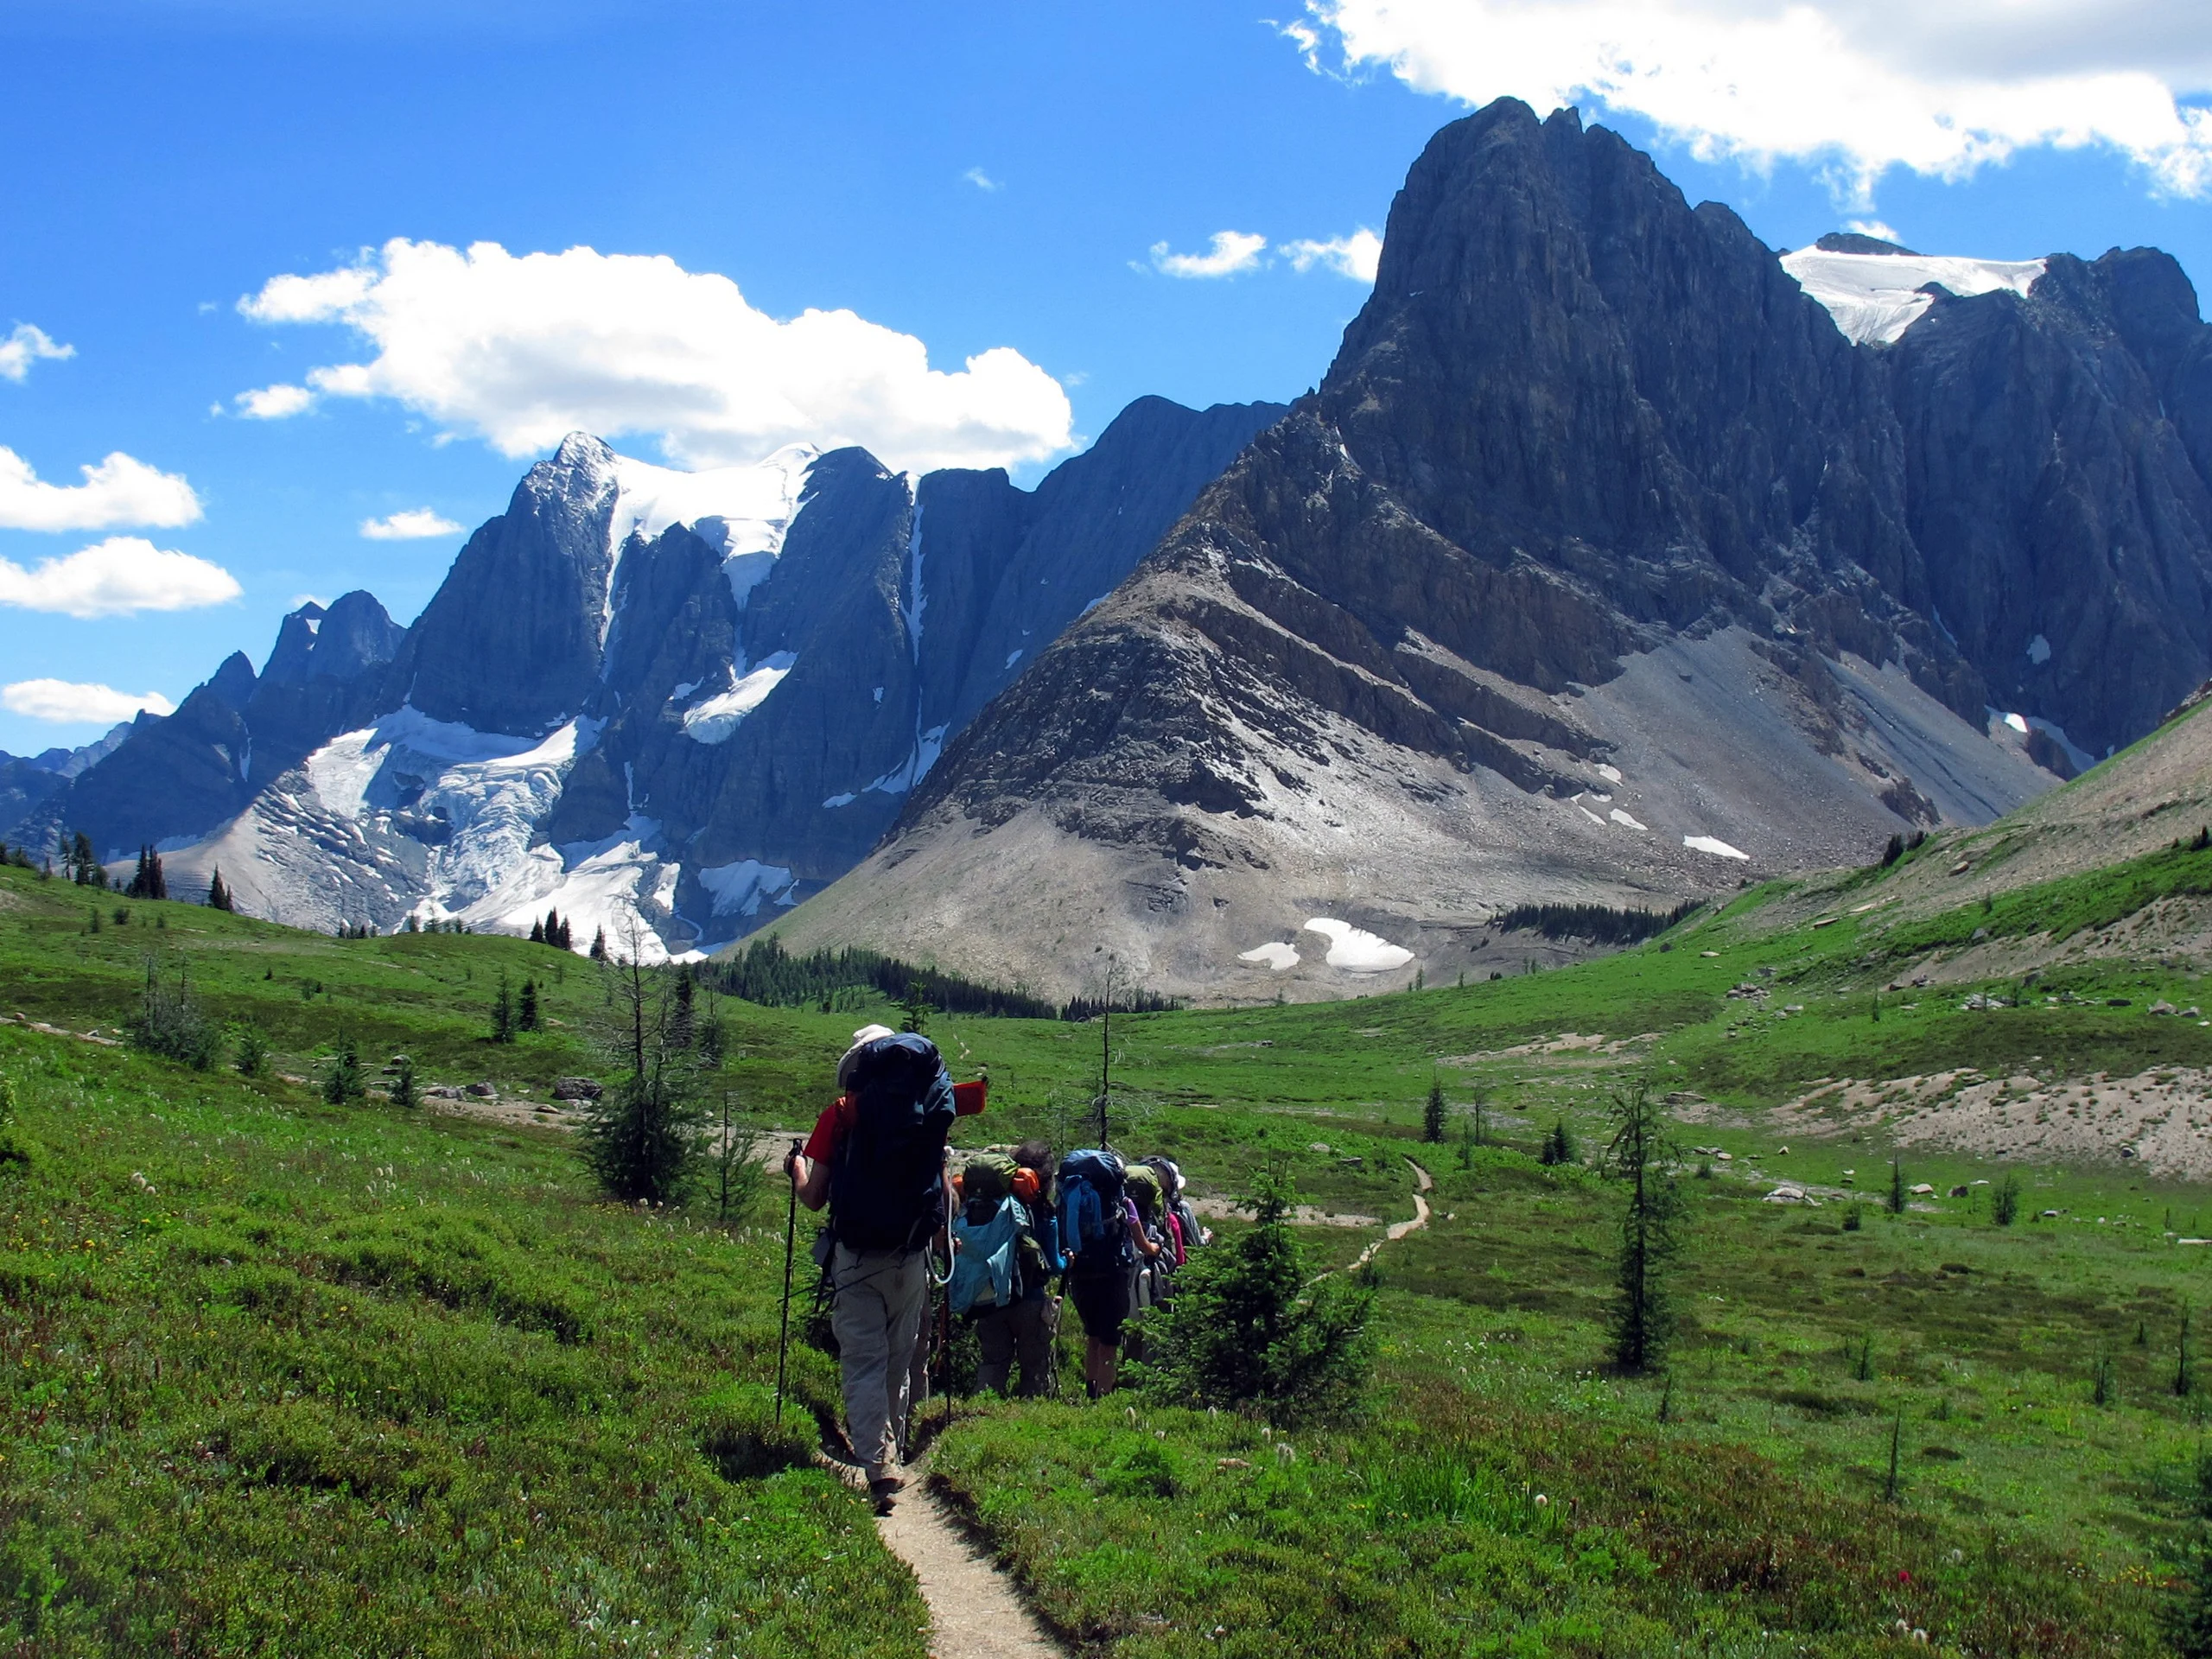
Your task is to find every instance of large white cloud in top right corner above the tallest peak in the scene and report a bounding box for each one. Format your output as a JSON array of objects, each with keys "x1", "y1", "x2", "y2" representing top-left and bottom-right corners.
[{"x1": 1285, "y1": 0, "x2": 2212, "y2": 201}]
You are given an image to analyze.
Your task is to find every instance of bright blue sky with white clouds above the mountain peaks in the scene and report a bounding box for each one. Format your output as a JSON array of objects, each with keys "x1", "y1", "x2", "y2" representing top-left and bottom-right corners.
[{"x1": 0, "y1": 0, "x2": 2212, "y2": 754}]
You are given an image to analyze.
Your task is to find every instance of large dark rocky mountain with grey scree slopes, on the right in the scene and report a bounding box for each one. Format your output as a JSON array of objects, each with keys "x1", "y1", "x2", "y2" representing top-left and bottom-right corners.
[{"x1": 779, "y1": 102, "x2": 2212, "y2": 995}]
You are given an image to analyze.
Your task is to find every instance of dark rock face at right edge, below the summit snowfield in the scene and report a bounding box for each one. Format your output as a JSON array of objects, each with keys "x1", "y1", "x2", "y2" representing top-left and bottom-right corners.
[{"x1": 1885, "y1": 250, "x2": 2212, "y2": 754}]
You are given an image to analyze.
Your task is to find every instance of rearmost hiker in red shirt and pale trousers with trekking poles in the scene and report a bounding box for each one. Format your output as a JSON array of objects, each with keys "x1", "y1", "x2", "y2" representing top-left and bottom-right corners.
[{"x1": 783, "y1": 1027, "x2": 984, "y2": 1513}]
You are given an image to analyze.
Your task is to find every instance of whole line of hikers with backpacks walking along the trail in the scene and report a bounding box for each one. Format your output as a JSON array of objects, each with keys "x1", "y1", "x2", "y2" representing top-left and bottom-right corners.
[{"x1": 783, "y1": 1027, "x2": 1212, "y2": 1510}]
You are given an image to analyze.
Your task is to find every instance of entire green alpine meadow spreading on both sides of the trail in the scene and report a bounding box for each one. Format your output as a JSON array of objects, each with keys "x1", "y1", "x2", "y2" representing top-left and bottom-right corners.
[{"x1": 0, "y1": 849, "x2": 2212, "y2": 1656}]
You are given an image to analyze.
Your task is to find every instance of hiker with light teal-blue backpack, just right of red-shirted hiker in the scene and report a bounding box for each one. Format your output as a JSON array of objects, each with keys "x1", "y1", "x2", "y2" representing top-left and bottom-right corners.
[{"x1": 947, "y1": 1153, "x2": 1058, "y2": 1398}]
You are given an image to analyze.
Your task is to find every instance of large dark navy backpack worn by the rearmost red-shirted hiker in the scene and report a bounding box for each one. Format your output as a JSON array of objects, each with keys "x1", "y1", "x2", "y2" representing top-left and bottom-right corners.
[{"x1": 830, "y1": 1031, "x2": 953, "y2": 1249}]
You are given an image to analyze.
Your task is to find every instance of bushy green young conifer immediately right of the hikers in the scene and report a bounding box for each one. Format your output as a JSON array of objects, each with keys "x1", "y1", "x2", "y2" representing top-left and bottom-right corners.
[{"x1": 1130, "y1": 1173, "x2": 1374, "y2": 1425}]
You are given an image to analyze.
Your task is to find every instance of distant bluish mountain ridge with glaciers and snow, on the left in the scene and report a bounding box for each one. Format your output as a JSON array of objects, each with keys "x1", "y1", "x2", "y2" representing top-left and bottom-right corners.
[{"x1": 27, "y1": 398, "x2": 1281, "y2": 956}]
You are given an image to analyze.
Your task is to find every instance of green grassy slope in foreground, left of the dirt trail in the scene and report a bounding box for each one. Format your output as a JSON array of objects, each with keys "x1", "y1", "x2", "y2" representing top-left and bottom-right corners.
[{"x1": 0, "y1": 955, "x2": 927, "y2": 1655}]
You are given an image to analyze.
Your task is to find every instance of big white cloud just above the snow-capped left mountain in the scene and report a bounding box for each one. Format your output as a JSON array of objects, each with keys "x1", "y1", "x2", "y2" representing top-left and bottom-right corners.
[{"x1": 238, "y1": 238, "x2": 1073, "y2": 471}]
